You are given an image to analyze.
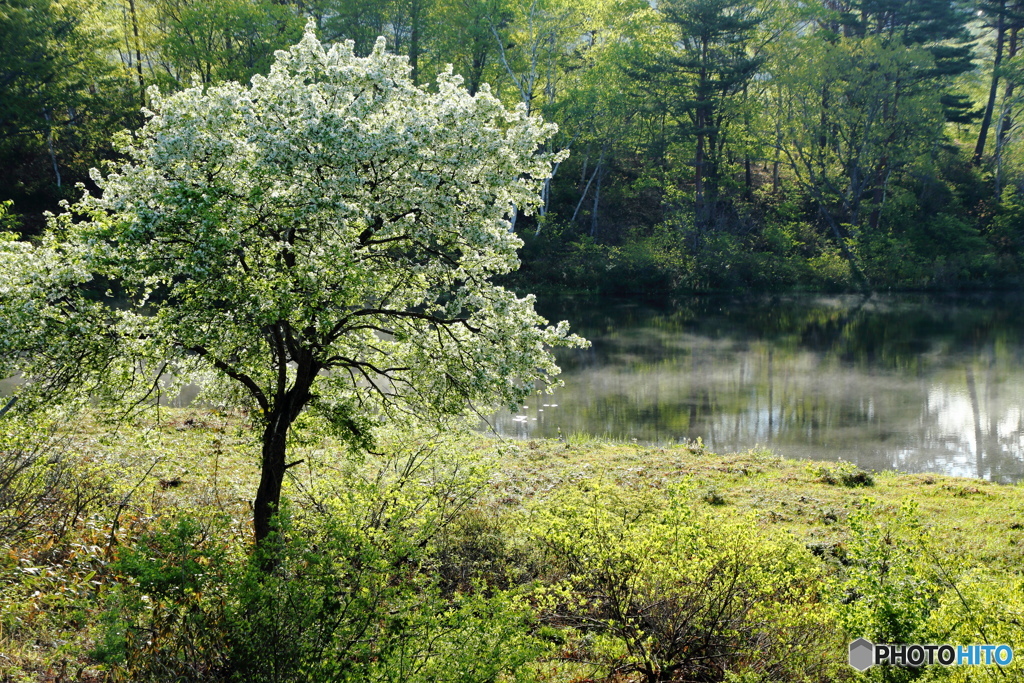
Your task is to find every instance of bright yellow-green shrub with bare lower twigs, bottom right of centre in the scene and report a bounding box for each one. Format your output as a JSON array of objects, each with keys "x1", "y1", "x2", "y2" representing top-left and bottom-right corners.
[{"x1": 530, "y1": 482, "x2": 837, "y2": 682}]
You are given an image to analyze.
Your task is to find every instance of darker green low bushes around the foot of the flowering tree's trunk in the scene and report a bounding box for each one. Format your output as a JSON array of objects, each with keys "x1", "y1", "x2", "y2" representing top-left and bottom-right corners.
[{"x1": 104, "y1": 505, "x2": 542, "y2": 683}]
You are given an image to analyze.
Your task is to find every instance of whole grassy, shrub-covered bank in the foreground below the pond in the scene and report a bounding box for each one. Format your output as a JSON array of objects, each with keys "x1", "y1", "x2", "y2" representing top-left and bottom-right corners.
[{"x1": 0, "y1": 410, "x2": 1024, "y2": 681}]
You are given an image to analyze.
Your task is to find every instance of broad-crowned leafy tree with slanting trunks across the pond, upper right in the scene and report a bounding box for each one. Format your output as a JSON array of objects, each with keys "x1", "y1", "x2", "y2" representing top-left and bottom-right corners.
[{"x1": 779, "y1": 37, "x2": 941, "y2": 278}]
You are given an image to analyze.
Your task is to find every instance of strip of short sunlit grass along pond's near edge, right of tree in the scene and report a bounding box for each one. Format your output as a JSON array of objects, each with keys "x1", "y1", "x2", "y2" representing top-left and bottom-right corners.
[{"x1": 483, "y1": 439, "x2": 1024, "y2": 570}]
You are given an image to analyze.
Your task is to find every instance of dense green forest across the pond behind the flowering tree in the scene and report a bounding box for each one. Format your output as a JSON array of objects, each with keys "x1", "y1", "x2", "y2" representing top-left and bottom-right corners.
[{"x1": 6, "y1": 0, "x2": 1024, "y2": 296}]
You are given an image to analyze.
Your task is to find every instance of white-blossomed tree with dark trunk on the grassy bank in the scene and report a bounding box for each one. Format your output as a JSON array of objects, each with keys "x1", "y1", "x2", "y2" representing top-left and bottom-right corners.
[{"x1": 0, "y1": 29, "x2": 584, "y2": 542}]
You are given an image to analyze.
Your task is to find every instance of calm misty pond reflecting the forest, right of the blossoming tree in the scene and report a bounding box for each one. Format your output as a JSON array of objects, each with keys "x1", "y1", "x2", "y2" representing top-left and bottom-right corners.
[{"x1": 490, "y1": 294, "x2": 1024, "y2": 482}]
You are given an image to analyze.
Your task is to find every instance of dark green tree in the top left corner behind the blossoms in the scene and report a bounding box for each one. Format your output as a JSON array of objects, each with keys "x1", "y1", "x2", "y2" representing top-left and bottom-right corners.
[{"x1": 0, "y1": 0, "x2": 136, "y2": 231}]
